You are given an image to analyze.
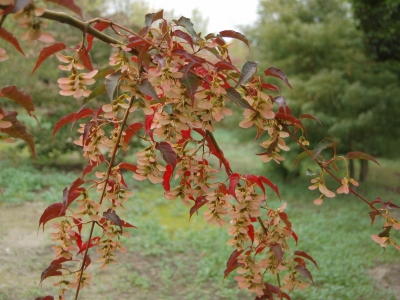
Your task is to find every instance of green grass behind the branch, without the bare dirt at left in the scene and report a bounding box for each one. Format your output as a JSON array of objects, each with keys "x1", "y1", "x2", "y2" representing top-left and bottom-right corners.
[{"x1": 0, "y1": 132, "x2": 400, "y2": 300}]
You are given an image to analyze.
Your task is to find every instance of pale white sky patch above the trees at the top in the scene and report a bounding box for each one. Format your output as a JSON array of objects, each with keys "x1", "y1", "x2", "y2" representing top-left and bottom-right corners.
[{"x1": 145, "y1": 0, "x2": 258, "y2": 33}]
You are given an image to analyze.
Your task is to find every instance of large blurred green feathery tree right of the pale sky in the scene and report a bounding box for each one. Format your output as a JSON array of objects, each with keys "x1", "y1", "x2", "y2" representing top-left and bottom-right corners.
[{"x1": 248, "y1": 0, "x2": 400, "y2": 180}]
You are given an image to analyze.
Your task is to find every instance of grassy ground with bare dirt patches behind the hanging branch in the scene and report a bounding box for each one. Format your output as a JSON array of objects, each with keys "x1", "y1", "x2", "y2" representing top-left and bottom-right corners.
[{"x1": 0, "y1": 134, "x2": 400, "y2": 300}]
